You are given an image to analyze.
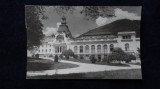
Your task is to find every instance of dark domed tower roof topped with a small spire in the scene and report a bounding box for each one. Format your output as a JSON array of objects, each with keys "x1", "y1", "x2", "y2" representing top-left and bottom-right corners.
[{"x1": 57, "y1": 17, "x2": 72, "y2": 37}]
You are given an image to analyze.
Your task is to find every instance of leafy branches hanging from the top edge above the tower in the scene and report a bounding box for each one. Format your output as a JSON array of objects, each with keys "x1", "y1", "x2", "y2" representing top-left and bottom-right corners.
[{"x1": 54, "y1": 6, "x2": 115, "y2": 20}]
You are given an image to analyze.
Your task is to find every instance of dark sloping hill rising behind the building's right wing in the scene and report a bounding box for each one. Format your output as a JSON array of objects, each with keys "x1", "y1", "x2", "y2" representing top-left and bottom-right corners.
[{"x1": 77, "y1": 19, "x2": 140, "y2": 38}]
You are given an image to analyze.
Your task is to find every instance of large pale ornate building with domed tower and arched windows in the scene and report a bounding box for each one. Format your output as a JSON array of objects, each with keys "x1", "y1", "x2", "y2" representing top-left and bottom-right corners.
[{"x1": 36, "y1": 17, "x2": 140, "y2": 59}]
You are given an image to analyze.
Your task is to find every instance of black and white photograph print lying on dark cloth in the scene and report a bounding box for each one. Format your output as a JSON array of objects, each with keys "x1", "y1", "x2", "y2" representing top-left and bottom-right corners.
[{"x1": 25, "y1": 5, "x2": 142, "y2": 79}]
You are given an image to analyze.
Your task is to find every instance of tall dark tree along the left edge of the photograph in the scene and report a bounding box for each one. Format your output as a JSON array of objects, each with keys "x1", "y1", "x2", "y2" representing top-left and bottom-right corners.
[{"x1": 25, "y1": 6, "x2": 44, "y2": 50}]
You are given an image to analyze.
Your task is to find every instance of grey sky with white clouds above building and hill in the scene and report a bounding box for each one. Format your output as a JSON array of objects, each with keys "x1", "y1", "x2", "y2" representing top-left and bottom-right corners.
[{"x1": 42, "y1": 6, "x2": 141, "y2": 37}]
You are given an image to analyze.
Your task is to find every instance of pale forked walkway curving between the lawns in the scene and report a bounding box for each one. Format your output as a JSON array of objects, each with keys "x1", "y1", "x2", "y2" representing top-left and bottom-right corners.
[{"x1": 27, "y1": 58, "x2": 141, "y2": 76}]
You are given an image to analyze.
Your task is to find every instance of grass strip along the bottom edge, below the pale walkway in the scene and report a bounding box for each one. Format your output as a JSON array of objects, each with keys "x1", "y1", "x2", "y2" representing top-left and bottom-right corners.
[{"x1": 27, "y1": 69, "x2": 142, "y2": 79}]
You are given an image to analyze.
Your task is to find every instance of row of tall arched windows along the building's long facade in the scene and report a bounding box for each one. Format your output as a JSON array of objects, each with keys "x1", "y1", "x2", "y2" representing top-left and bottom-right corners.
[{"x1": 74, "y1": 44, "x2": 114, "y2": 53}]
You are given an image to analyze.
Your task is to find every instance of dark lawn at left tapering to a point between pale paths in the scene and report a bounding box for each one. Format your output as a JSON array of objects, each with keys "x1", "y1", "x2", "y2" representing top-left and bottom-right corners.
[{"x1": 27, "y1": 58, "x2": 78, "y2": 71}]
